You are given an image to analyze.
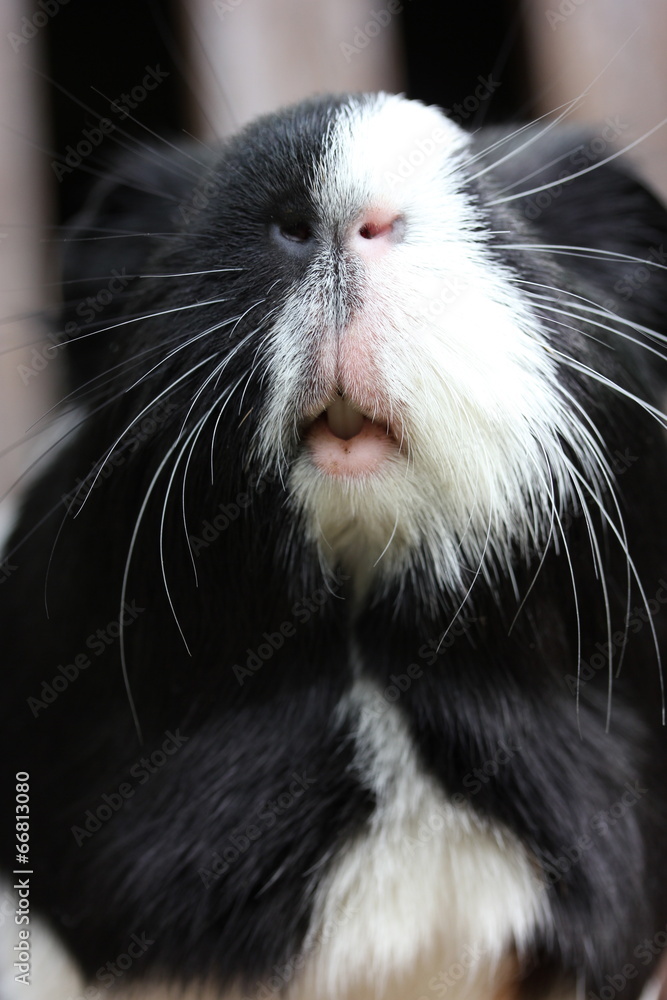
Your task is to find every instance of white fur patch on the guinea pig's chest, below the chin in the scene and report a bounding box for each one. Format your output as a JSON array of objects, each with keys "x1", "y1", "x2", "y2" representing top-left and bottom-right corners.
[{"x1": 298, "y1": 681, "x2": 548, "y2": 1000}]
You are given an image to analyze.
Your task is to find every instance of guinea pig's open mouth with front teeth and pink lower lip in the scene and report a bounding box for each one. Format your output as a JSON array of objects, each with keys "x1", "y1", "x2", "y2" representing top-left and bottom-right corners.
[{"x1": 303, "y1": 394, "x2": 399, "y2": 478}]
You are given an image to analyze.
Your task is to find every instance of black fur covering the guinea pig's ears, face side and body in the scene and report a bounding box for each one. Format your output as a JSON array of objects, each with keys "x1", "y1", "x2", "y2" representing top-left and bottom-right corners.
[{"x1": 0, "y1": 100, "x2": 667, "y2": 1000}]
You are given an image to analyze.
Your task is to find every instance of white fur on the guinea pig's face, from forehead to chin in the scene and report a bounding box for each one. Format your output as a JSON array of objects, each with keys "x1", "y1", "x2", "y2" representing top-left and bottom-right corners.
[{"x1": 253, "y1": 95, "x2": 606, "y2": 591}]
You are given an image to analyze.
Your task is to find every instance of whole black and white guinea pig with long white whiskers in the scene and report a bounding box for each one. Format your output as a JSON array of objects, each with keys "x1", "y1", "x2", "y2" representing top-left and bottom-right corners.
[{"x1": 0, "y1": 94, "x2": 667, "y2": 1000}]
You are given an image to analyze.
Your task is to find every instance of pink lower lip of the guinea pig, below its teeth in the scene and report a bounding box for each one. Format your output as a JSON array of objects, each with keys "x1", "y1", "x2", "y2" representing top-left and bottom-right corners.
[{"x1": 304, "y1": 413, "x2": 398, "y2": 479}]
